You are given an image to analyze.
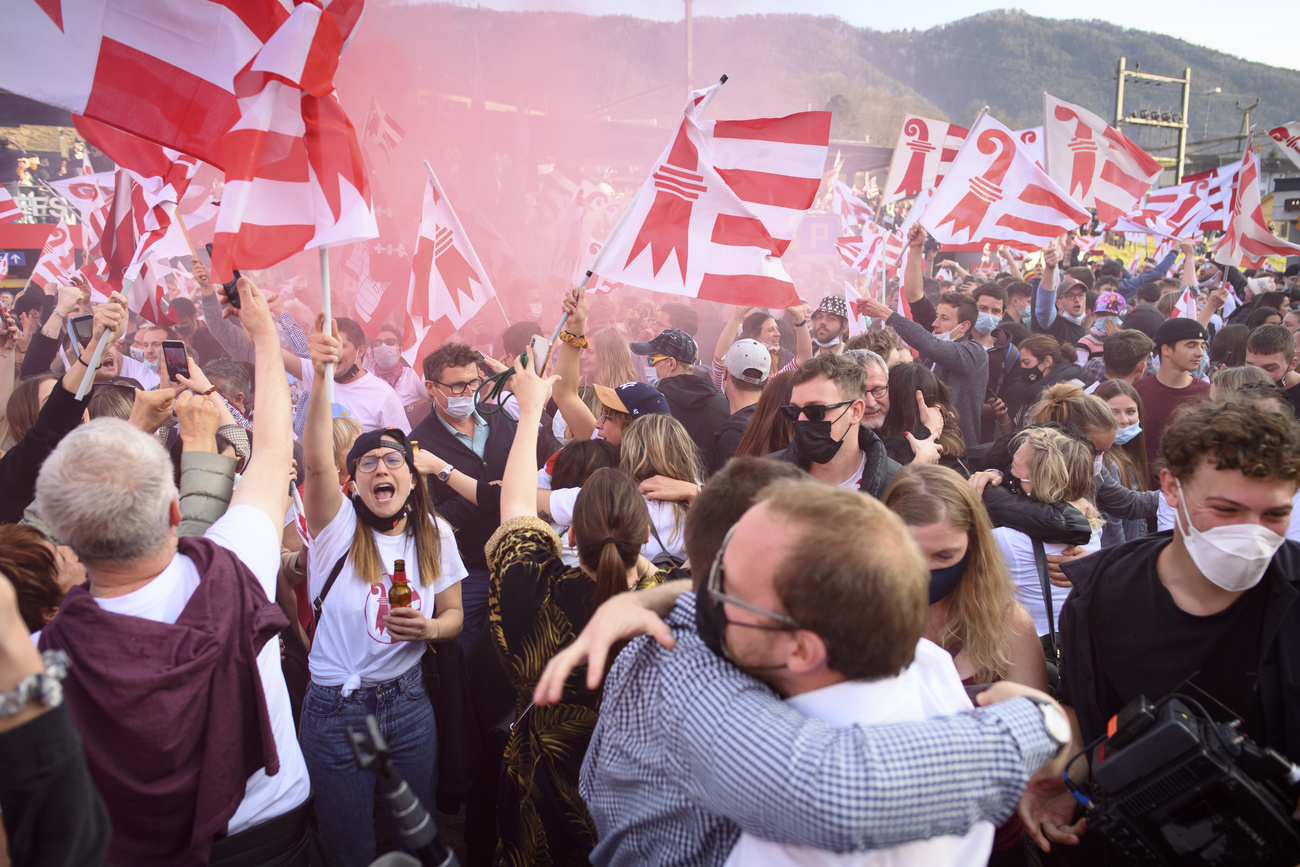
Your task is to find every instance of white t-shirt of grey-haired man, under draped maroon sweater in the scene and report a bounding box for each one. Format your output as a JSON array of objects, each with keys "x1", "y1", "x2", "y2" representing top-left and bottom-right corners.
[{"x1": 95, "y1": 506, "x2": 312, "y2": 835}]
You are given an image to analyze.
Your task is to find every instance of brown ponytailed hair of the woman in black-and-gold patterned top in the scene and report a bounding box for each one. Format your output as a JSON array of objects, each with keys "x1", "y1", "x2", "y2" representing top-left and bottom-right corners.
[{"x1": 573, "y1": 467, "x2": 650, "y2": 610}]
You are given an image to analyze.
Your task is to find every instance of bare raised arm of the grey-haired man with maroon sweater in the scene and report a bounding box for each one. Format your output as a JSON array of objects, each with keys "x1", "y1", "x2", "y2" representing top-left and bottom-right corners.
[{"x1": 230, "y1": 277, "x2": 294, "y2": 528}]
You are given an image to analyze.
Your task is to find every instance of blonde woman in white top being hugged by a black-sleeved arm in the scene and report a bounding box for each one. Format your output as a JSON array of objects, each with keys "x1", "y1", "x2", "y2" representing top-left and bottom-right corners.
[{"x1": 993, "y1": 428, "x2": 1102, "y2": 636}]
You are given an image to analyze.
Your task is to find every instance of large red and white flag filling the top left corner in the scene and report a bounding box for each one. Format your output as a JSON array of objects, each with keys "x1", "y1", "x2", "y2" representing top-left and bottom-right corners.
[{"x1": 0, "y1": 0, "x2": 287, "y2": 165}]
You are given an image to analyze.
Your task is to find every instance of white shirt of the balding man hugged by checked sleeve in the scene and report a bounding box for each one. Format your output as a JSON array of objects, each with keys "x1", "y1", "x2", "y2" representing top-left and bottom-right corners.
[{"x1": 727, "y1": 638, "x2": 995, "y2": 867}]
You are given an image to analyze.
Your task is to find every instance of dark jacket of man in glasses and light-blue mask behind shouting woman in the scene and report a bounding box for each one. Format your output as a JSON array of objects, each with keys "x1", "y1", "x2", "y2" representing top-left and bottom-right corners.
[{"x1": 410, "y1": 409, "x2": 560, "y2": 572}]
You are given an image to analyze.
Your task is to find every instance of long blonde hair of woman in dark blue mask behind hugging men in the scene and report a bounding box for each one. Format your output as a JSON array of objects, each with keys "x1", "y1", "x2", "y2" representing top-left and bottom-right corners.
[{"x1": 884, "y1": 464, "x2": 1015, "y2": 684}]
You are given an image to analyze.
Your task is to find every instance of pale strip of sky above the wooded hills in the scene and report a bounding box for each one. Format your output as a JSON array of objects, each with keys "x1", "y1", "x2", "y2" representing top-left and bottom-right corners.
[{"x1": 436, "y1": 0, "x2": 1300, "y2": 69}]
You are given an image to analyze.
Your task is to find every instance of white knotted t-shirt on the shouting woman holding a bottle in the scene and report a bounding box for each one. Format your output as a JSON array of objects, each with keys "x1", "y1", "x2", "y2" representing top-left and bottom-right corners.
[{"x1": 307, "y1": 499, "x2": 467, "y2": 695}]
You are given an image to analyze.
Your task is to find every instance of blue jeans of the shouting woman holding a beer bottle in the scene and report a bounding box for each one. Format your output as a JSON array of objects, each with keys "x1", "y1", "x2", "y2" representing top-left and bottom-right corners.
[{"x1": 298, "y1": 664, "x2": 438, "y2": 867}]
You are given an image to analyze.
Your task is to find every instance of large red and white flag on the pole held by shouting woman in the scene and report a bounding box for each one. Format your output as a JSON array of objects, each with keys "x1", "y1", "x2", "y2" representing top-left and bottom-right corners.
[{"x1": 212, "y1": 0, "x2": 378, "y2": 279}]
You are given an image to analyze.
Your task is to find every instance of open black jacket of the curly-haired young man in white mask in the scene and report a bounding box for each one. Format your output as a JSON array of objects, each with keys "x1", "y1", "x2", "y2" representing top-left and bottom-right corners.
[{"x1": 1061, "y1": 530, "x2": 1300, "y2": 762}]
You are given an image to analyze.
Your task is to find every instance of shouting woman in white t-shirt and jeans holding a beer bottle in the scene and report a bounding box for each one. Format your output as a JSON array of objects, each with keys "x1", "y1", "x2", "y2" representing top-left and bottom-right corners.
[{"x1": 299, "y1": 318, "x2": 465, "y2": 867}]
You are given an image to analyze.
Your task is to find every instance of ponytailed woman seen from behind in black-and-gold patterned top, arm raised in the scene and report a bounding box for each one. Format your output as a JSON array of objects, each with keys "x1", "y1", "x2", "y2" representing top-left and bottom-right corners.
[{"x1": 486, "y1": 350, "x2": 665, "y2": 867}]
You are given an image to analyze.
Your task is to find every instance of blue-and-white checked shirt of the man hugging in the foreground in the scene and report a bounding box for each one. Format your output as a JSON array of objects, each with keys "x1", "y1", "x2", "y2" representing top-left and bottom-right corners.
[{"x1": 581, "y1": 593, "x2": 1056, "y2": 864}]
